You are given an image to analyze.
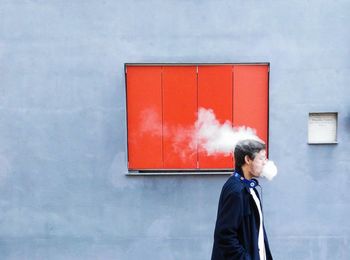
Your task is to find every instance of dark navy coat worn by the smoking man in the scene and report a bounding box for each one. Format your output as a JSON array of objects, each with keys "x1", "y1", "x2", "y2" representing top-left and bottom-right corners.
[{"x1": 211, "y1": 176, "x2": 272, "y2": 260}]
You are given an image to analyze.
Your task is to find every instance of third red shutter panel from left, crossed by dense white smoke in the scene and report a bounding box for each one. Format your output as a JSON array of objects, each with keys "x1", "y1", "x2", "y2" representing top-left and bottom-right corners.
[{"x1": 198, "y1": 66, "x2": 233, "y2": 169}]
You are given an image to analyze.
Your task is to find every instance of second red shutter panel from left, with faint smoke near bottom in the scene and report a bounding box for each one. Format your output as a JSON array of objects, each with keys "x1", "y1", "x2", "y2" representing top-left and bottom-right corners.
[{"x1": 162, "y1": 66, "x2": 197, "y2": 169}]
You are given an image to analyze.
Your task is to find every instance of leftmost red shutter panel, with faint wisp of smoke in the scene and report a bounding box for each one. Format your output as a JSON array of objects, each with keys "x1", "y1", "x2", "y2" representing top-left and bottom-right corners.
[{"x1": 126, "y1": 66, "x2": 163, "y2": 169}]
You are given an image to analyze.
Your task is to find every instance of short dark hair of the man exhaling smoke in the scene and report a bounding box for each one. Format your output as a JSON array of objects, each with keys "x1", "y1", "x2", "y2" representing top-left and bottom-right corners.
[{"x1": 234, "y1": 139, "x2": 266, "y2": 173}]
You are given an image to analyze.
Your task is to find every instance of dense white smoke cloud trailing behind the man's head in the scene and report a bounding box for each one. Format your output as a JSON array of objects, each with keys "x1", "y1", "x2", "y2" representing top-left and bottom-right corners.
[{"x1": 190, "y1": 108, "x2": 262, "y2": 156}]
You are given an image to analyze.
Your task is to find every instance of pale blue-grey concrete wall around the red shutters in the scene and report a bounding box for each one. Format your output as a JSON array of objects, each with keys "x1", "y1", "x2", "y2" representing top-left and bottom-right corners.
[{"x1": 0, "y1": 0, "x2": 350, "y2": 260}]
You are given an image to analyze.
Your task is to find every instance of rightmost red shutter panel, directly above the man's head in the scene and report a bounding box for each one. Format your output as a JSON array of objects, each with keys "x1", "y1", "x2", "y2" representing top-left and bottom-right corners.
[{"x1": 233, "y1": 65, "x2": 268, "y2": 149}]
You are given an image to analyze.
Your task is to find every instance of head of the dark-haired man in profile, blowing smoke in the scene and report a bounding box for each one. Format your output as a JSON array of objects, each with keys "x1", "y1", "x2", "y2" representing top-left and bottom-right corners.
[{"x1": 234, "y1": 139, "x2": 266, "y2": 179}]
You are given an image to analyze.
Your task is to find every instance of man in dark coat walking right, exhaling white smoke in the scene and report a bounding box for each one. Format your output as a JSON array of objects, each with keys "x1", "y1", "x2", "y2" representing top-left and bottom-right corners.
[{"x1": 211, "y1": 139, "x2": 272, "y2": 260}]
